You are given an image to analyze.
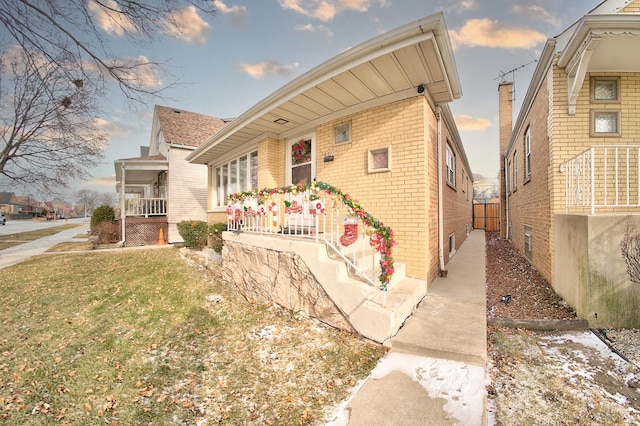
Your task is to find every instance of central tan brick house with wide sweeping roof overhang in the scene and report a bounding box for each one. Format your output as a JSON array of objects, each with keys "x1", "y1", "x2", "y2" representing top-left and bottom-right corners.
[{"x1": 187, "y1": 14, "x2": 473, "y2": 342}]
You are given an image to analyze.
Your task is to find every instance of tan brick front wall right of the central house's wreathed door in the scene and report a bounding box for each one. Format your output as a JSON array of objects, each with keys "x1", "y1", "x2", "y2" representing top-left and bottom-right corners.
[{"x1": 316, "y1": 97, "x2": 429, "y2": 279}]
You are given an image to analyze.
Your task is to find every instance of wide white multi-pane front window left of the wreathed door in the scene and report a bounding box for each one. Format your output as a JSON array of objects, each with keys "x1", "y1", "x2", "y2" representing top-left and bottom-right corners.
[{"x1": 212, "y1": 151, "x2": 258, "y2": 208}]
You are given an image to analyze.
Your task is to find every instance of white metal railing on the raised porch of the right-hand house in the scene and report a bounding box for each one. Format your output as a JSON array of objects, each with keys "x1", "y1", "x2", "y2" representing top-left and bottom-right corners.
[{"x1": 561, "y1": 145, "x2": 640, "y2": 214}]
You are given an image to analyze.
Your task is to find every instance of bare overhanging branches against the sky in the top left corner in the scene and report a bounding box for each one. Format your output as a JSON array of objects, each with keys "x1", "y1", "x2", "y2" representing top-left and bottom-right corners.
[{"x1": 0, "y1": 0, "x2": 215, "y2": 102}]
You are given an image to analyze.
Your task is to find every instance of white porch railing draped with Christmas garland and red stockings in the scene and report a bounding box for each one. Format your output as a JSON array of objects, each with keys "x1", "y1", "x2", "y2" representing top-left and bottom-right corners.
[{"x1": 227, "y1": 182, "x2": 394, "y2": 290}]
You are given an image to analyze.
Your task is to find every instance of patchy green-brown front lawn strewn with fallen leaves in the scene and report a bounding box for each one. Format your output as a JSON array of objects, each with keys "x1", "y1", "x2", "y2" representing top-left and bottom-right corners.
[{"x1": 0, "y1": 248, "x2": 385, "y2": 425}]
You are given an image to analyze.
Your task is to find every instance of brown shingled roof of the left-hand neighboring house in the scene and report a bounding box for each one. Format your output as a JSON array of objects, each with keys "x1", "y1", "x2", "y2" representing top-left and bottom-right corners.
[{"x1": 155, "y1": 105, "x2": 229, "y2": 147}]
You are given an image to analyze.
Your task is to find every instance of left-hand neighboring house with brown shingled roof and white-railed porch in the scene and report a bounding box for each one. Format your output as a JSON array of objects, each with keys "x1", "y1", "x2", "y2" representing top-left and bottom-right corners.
[{"x1": 115, "y1": 105, "x2": 227, "y2": 245}]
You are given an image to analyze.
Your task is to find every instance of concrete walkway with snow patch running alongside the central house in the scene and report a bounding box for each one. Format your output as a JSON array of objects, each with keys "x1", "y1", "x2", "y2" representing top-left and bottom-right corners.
[{"x1": 329, "y1": 230, "x2": 487, "y2": 426}]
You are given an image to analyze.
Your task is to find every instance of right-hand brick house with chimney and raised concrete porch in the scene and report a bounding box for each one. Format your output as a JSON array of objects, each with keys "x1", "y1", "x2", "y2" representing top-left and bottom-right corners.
[{"x1": 499, "y1": 0, "x2": 640, "y2": 327}]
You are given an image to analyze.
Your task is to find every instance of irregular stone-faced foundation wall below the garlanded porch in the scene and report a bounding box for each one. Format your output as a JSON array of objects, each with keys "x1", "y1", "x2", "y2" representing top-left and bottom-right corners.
[{"x1": 222, "y1": 240, "x2": 355, "y2": 332}]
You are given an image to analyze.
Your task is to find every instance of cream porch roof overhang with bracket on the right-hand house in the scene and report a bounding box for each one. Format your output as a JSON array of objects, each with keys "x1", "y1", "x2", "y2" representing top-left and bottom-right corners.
[{"x1": 558, "y1": 14, "x2": 640, "y2": 114}]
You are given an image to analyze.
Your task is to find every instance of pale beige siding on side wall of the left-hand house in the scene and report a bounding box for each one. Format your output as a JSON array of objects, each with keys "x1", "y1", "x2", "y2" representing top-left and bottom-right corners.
[{"x1": 167, "y1": 147, "x2": 207, "y2": 243}]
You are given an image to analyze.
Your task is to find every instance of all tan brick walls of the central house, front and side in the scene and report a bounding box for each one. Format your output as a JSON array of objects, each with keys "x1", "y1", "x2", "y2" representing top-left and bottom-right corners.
[{"x1": 208, "y1": 97, "x2": 473, "y2": 283}]
